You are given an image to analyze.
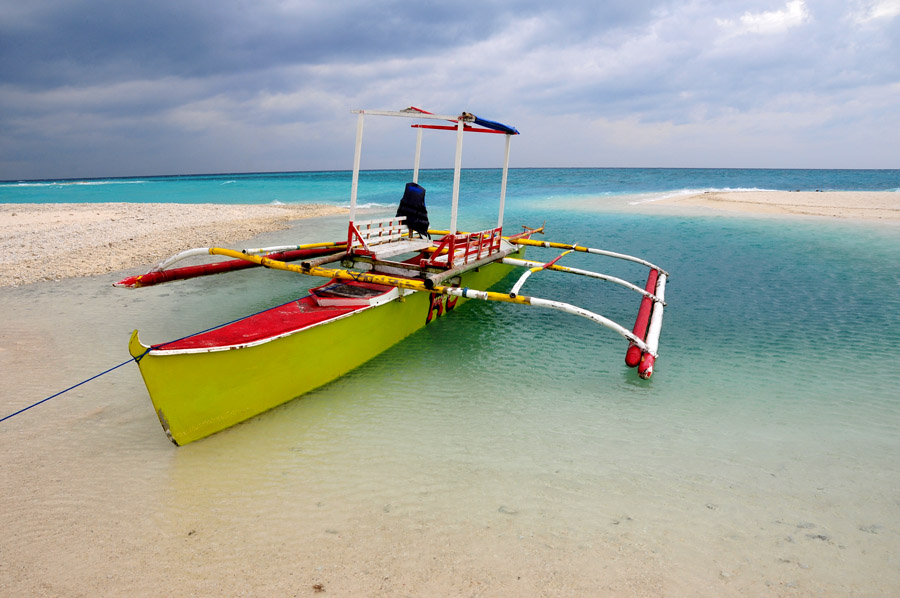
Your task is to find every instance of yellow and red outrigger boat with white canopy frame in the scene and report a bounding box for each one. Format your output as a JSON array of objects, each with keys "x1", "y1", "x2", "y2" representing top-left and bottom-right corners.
[{"x1": 116, "y1": 108, "x2": 668, "y2": 445}]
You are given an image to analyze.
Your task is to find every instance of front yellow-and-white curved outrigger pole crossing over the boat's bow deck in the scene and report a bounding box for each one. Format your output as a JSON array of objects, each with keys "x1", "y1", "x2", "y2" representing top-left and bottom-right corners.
[{"x1": 209, "y1": 246, "x2": 657, "y2": 357}]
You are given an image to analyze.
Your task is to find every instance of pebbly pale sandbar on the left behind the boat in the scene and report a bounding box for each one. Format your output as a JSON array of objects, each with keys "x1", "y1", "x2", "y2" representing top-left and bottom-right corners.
[{"x1": 0, "y1": 203, "x2": 346, "y2": 287}]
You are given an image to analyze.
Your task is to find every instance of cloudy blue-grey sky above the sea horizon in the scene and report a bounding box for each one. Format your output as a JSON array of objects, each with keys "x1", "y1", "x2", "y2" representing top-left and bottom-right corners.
[{"x1": 0, "y1": 0, "x2": 900, "y2": 179}]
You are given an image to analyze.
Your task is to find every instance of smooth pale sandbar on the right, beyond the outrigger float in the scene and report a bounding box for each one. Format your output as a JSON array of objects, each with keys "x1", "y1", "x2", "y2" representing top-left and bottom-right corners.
[{"x1": 652, "y1": 191, "x2": 900, "y2": 222}]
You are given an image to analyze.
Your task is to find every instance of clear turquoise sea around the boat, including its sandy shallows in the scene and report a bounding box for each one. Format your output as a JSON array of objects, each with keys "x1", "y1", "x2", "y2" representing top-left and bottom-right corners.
[{"x1": 0, "y1": 169, "x2": 900, "y2": 596}]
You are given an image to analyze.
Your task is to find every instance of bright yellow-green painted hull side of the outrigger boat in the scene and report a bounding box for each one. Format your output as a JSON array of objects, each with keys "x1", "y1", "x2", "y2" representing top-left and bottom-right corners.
[{"x1": 129, "y1": 258, "x2": 524, "y2": 445}]
